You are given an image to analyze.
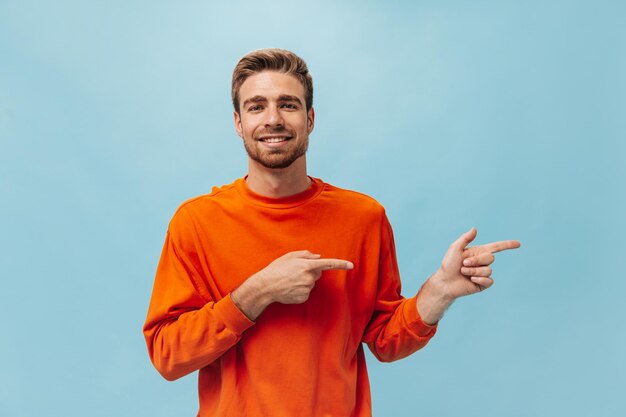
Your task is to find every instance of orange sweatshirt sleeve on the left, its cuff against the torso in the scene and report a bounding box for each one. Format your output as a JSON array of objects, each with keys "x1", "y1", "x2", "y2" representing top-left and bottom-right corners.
[{"x1": 143, "y1": 219, "x2": 254, "y2": 380}]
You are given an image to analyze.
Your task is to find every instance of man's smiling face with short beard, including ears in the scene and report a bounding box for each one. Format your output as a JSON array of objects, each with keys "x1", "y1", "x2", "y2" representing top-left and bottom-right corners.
[{"x1": 235, "y1": 71, "x2": 315, "y2": 169}]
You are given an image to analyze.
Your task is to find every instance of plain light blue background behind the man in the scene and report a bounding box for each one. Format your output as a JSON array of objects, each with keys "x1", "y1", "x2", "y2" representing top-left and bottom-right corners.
[{"x1": 0, "y1": 0, "x2": 626, "y2": 417}]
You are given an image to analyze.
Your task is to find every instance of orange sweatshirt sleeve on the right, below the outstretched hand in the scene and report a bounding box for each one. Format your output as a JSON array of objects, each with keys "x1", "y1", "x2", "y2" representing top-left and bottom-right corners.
[{"x1": 363, "y1": 215, "x2": 437, "y2": 362}]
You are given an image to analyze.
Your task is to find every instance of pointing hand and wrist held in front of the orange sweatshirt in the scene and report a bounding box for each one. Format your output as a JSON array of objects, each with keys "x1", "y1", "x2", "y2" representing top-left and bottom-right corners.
[{"x1": 231, "y1": 250, "x2": 353, "y2": 320}]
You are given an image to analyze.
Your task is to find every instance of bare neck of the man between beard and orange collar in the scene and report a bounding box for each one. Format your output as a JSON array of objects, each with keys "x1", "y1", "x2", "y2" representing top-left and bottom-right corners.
[{"x1": 246, "y1": 156, "x2": 311, "y2": 198}]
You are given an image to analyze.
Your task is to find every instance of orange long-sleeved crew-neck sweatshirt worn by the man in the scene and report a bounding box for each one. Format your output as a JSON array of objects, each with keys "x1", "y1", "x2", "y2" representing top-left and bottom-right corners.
[{"x1": 144, "y1": 178, "x2": 436, "y2": 417}]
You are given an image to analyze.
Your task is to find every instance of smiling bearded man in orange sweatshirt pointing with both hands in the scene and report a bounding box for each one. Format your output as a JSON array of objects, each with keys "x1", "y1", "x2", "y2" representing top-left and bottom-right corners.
[{"x1": 144, "y1": 49, "x2": 519, "y2": 417}]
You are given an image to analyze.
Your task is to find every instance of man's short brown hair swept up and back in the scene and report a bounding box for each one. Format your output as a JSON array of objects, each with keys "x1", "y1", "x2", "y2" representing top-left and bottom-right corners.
[{"x1": 231, "y1": 48, "x2": 313, "y2": 113}]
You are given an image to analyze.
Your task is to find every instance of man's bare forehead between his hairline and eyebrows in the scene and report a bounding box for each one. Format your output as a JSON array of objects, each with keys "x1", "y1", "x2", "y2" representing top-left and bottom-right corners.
[{"x1": 239, "y1": 71, "x2": 304, "y2": 102}]
